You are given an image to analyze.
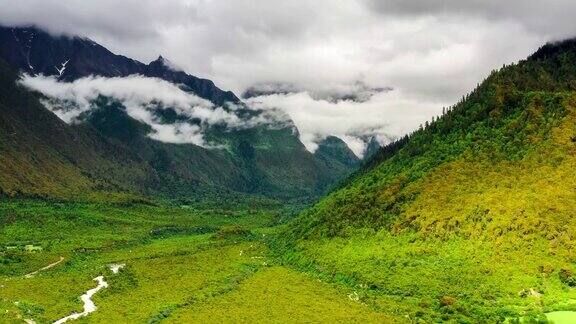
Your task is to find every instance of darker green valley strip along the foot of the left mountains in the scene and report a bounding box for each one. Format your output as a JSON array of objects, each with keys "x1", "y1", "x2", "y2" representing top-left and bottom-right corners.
[{"x1": 0, "y1": 201, "x2": 278, "y2": 275}]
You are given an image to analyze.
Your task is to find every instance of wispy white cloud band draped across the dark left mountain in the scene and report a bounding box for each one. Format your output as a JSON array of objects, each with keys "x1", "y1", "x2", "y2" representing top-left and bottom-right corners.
[{"x1": 20, "y1": 75, "x2": 246, "y2": 147}]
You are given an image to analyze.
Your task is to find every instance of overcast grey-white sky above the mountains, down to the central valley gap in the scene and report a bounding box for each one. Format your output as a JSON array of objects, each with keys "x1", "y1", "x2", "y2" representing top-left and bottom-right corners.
[{"x1": 0, "y1": 0, "x2": 576, "y2": 153}]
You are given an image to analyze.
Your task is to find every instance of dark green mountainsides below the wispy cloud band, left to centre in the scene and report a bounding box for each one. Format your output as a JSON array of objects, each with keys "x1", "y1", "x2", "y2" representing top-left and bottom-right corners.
[{"x1": 0, "y1": 60, "x2": 357, "y2": 204}]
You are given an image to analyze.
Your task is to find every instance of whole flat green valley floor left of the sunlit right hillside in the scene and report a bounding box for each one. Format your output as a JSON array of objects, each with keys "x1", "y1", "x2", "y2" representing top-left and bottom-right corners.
[{"x1": 0, "y1": 201, "x2": 391, "y2": 323}]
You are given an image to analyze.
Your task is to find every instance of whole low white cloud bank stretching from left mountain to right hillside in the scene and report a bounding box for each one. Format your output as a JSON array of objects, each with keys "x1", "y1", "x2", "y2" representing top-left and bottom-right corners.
[{"x1": 20, "y1": 75, "x2": 438, "y2": 157}]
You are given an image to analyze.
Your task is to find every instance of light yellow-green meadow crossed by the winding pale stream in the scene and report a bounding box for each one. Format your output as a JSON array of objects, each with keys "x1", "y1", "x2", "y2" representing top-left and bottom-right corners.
[{"x1": 2, "y1": 235, "x2": 263, "y2": 323}]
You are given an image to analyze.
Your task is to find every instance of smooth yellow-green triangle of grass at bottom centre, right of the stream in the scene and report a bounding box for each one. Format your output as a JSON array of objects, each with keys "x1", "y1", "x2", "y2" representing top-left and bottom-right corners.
[{"x1": 169, "y1": 266, "x2": 392, "y2": 323}]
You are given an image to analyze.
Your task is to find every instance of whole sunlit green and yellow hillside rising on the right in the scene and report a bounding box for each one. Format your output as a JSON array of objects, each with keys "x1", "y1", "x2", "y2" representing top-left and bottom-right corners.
[{"x1": 288, "y1": 40, "x2": 576, "y2": 322}]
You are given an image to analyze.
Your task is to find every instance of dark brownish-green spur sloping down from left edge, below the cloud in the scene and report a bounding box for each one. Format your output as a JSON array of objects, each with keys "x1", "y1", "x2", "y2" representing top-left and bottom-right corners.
[{"x1": 0, "y1": 60, "x2": 158, "y2": 198}]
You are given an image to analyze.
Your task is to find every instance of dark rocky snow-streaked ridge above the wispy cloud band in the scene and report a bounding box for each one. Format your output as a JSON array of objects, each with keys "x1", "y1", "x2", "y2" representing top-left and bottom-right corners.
[{"x1": 0, "y1": 26, "x2": 239, "y2": 105}]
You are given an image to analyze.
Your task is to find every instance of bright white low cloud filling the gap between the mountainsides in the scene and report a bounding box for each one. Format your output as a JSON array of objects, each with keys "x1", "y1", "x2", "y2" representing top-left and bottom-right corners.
[{"x1": 247, "y1": 90, "x2": 442, "y2": 157}]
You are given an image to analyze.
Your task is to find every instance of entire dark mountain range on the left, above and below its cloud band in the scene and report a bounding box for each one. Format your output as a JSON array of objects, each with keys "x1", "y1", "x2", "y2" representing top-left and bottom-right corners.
[{"x1": 0, "y1": 27, "x2": 368, "y2": 200}]
